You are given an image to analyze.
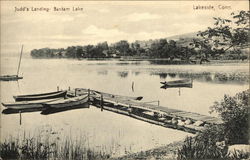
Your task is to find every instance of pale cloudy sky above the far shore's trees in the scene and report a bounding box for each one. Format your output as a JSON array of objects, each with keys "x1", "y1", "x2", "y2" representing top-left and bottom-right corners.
[{"x1": 0, "y1": 1, "x2": 249, "y2": 54}]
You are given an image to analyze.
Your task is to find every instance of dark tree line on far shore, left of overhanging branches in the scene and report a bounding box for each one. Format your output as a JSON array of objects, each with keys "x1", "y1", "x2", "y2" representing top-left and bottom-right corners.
[{"x1": 31, "y1": 39, "x2": 195, "y2": 58}]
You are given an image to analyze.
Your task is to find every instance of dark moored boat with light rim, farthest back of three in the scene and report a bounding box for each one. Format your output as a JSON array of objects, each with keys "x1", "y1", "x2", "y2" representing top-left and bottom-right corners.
[{"x1": 13, "y1": 91, "x2": 67, "y2": 102}]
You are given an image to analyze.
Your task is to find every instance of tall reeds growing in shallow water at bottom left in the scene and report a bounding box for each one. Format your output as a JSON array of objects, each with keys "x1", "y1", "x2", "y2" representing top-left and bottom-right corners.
[{"x1": 0, "y1": 133, "x2": 110, "y2": 160}]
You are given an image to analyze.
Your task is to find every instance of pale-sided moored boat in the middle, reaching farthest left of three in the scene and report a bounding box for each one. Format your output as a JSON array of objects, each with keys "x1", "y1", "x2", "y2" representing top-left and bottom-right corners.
[{"x1": 2, "y1": 98, "x2": 62, "y2": 110}]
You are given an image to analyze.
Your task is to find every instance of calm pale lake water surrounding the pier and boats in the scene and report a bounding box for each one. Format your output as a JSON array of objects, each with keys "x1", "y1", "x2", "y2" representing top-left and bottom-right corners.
[{"x1": 1, "y1": 57, "x2": 249, "y2": 156}]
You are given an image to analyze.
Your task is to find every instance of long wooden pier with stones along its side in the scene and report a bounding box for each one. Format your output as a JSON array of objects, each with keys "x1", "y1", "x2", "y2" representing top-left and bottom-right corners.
[{"x1": 67, "y1": 88, "x2": 222, "y2": 133}]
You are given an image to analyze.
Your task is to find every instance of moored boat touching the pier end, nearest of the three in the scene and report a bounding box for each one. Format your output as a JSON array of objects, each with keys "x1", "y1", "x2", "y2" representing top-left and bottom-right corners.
[{"x1": 43, "y1": 95, "x2": 88, "y2": 108}]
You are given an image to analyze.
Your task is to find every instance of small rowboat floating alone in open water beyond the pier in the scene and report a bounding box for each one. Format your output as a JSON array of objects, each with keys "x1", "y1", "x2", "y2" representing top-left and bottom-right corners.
[{"x1": 160, "y1": 79, "x2": 193, "y2": 88}]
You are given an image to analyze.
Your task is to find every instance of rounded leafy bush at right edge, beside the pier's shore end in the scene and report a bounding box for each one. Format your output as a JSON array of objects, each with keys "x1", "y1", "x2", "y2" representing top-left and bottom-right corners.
[{"x1": 211, "y1": 90, "x2": 250, "y2": 144}]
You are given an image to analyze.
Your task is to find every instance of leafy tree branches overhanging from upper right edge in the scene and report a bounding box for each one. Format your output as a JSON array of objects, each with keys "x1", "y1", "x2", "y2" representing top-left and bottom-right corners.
[{"x1": 198, "y1": 11, "x2": 250, "y2": 55}]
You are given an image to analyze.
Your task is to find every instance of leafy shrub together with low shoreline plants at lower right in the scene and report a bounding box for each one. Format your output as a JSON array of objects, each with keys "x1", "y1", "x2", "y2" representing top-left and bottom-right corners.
[{"x1": 177, "y1": 90, "x2": 250, "y2": 160}]
